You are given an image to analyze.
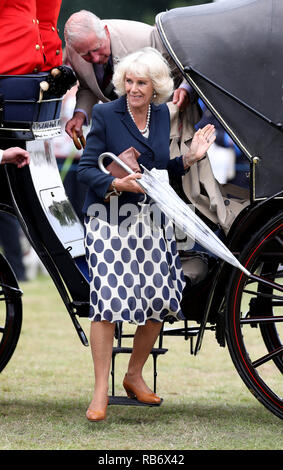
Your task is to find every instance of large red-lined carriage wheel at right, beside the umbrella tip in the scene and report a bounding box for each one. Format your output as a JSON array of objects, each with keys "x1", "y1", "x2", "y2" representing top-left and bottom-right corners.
[{"x1": 226, "y1": 214, "x2": 283, "y2": 419}]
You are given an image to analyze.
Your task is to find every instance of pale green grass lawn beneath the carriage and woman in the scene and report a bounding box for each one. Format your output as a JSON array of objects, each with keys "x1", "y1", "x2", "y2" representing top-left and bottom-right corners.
[{"x1": 0, "y1": 277, "x2": 282, "y2": 450}]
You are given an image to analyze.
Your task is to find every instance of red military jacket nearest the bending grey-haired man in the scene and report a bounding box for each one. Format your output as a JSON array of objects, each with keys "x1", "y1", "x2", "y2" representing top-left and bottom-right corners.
[{"x1": 36, "y1": 0, "x2": 63, "y2": 71}]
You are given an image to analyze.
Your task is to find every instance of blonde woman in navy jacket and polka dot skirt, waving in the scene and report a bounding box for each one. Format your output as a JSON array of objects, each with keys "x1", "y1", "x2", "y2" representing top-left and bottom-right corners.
[{"x1": 78, "y1": 48, "x2": 214, "y2": 421}]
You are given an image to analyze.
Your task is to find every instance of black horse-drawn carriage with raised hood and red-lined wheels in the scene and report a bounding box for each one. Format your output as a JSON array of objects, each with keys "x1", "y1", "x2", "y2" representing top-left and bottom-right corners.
[{"x1": 0, "y1": 0, "x2": 283, "y2": 418}]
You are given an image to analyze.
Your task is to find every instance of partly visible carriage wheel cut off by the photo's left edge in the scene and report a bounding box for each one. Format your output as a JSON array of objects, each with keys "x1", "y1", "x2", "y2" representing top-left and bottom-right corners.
[{"x1": 0, "y1": 256, "x2": 22, "y2": 372}]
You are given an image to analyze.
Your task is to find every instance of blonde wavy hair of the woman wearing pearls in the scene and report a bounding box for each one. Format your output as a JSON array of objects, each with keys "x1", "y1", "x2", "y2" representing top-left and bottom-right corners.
[{"x1": 113, "y1": 47, "x2": 174, "y2": 104}]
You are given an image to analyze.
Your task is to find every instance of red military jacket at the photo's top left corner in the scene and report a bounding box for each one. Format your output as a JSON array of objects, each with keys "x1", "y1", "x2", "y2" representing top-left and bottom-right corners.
[{"x1": 0, "y1": 0, "x2": 45, "y2": 75}]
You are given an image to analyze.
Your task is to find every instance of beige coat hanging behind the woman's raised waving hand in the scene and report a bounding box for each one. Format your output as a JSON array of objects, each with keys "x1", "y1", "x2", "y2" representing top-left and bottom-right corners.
[{"x1": 167, "y1": 103, "x2": 249, "y2": 234}]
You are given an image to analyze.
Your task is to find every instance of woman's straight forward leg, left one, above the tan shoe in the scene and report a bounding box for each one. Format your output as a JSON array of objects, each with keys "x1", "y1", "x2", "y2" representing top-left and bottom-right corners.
[{"x1": 89, "y1": 321, "x2": 115, "y2": 410}]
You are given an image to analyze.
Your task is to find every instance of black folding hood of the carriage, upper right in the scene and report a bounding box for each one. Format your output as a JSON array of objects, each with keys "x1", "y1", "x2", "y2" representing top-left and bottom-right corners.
[{"x1": 156, "y1": 0, "x2": 283, "y2": 199}]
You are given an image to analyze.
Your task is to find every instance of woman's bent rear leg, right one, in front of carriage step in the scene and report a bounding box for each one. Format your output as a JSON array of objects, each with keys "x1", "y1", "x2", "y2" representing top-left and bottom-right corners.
[{"x1": 126, "y1": 320, "x2": 162, "y2": 393}]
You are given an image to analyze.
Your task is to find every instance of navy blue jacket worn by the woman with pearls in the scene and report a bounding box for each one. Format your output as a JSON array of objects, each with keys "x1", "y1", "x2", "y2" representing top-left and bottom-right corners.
[{"x1": 78, "y1": 96, "x2": 185, "y2": 213}]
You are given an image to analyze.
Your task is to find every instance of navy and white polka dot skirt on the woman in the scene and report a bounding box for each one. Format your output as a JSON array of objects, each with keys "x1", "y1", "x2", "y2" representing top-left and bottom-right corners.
[{"x1": 85, "y1": 196, "x2": 185, "y2": 325}]
